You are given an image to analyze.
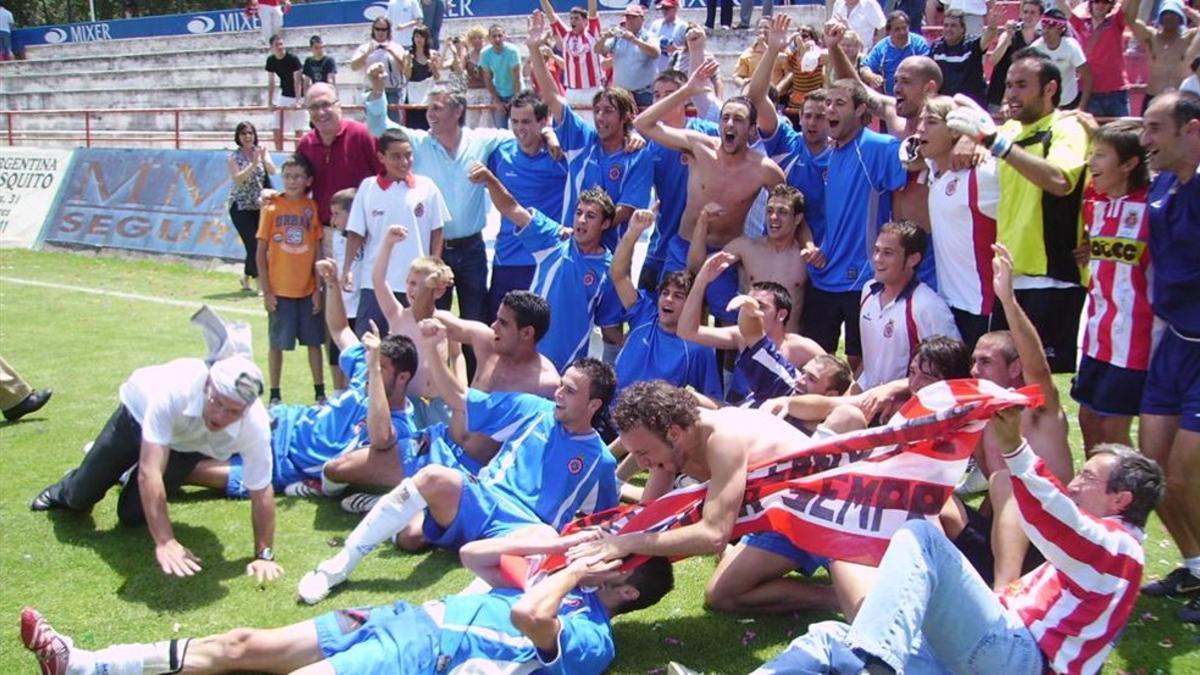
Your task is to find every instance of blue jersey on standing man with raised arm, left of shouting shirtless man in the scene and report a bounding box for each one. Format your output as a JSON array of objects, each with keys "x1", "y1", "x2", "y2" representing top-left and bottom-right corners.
[{"x1": 554, "y1": 106, "x2": 654, "y2": 251}]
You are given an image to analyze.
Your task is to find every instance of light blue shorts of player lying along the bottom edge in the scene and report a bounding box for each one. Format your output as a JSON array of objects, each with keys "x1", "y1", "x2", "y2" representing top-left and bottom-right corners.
[{"x1": 313, "y1": 601, "x2": 442, "y2": 675}]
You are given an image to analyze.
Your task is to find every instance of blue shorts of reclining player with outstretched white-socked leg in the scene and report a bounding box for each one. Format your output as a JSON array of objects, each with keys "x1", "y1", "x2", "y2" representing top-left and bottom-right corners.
[{"x1": 422, "y1": 476, "x2": 545, "y2": 549}]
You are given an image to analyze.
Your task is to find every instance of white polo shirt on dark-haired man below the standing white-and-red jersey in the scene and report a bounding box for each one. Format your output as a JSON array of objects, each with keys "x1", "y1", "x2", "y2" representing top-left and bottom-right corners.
[{"x1": 858, "y1": 277, "x2": 962, "y2": 390}]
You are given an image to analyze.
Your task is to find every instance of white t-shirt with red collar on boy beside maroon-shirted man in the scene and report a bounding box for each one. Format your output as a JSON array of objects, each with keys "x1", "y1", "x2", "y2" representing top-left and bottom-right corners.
[{"x1": 346, "y1": 174, "x2": 450, "y2": 293}]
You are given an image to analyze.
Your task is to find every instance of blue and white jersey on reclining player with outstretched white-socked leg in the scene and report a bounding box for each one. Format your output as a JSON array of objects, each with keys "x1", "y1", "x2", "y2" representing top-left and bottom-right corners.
[{"x1": 467, "y1": 389, "x2": 617, "y2": 530}]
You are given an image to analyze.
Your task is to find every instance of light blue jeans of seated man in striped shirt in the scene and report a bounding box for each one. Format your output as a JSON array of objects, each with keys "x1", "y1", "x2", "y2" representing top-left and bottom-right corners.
[{"x1": 756, "y1": 520, "x2": 1044, "y2": 675}]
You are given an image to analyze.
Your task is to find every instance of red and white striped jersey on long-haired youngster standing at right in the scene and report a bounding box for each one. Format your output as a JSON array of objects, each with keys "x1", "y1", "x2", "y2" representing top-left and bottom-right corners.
[{"x1": 1084, "y1": 185, "x2": 1156, "y2": 370}]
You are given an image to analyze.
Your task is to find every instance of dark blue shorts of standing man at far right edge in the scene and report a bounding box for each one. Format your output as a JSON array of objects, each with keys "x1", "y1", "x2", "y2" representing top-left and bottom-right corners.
[{"x1": 1141, "y1": 329, "x2": 1200, "y2": 432}]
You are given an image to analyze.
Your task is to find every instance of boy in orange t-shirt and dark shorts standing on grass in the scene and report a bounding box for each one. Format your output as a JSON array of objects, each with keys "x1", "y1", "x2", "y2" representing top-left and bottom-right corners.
[{"x1": 257, "y1": 154, "x2": 325, "y2": 405}]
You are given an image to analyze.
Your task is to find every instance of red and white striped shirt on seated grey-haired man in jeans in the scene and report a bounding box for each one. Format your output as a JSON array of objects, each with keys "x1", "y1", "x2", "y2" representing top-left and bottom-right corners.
[{"x1": 1000, "y1": 443, "x2": 1145, "y2": 674}]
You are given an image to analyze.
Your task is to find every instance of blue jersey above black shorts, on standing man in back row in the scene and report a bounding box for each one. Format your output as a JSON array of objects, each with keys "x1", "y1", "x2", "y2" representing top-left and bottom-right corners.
[{"x1": 809, "y1": 129, "x2": 908, "y2": 293}]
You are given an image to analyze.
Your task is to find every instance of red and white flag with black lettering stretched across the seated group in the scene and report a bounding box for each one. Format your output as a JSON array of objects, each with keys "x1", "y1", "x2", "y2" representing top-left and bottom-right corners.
[{"x1": 514, "y1": 380, "x2": 1042, "y2": 572}]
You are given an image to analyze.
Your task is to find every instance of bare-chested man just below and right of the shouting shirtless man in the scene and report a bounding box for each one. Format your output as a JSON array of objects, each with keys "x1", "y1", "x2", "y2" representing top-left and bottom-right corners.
[{"x1": 688, "y1": 183, "x2": 820, "y2": 333}]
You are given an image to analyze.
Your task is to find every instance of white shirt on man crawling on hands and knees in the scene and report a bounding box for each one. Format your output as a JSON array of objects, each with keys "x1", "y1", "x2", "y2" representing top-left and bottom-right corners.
[{"x1": 120, "y1": 359, "x2": 271, "y2": 490}]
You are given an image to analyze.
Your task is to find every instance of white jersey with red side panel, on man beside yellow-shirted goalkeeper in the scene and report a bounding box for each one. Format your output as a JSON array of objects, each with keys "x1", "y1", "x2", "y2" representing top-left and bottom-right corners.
[{"x1": 928, "y1": 157, "x2": 1000, "y2": 315}]
